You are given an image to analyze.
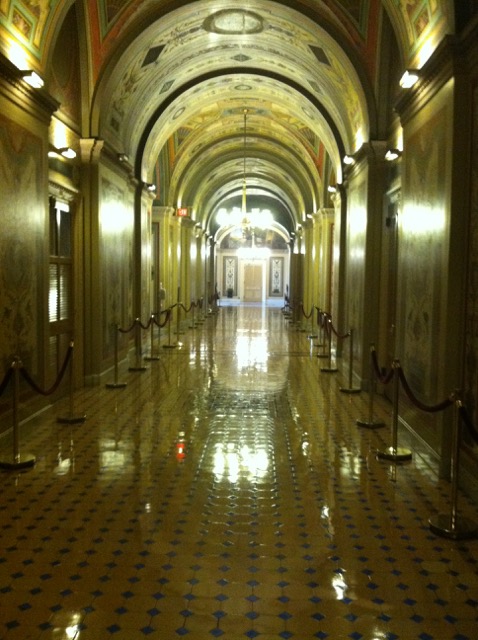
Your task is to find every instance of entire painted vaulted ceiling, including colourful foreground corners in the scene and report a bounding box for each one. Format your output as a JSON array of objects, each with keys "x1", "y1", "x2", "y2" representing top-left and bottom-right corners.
[{"x1": 0, "y1": 0, "x2": 453, "y2": 226}]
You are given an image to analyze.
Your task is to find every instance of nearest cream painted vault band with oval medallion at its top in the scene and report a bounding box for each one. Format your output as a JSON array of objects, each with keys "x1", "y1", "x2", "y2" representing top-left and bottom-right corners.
[{"x1": 99, "y1": 3, "x2": 368, "y2": 168}]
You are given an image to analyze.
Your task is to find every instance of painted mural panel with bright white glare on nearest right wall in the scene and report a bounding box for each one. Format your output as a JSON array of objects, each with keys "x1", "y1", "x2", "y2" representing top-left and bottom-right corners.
[{"x1": 399, "y1": 107, "x2": 448, "y2": 401}]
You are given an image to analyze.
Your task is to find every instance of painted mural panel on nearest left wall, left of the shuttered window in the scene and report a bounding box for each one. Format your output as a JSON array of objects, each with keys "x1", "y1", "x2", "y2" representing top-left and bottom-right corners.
[{"x1": 0, "y1": 115, "x2": 46, "y2": 374}]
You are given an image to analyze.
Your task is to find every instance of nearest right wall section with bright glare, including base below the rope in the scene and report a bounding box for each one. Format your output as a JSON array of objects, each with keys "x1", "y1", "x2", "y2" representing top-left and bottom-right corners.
[{"x1": 397, "y1": 85, "x2": 454, "y2": 453}]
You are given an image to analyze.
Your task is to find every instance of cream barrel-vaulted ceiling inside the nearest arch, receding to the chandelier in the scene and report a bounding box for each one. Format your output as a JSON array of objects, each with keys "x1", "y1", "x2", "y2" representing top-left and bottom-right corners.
[{"x1": 94, "y1": 0, "x2": 374, "y2": 230}]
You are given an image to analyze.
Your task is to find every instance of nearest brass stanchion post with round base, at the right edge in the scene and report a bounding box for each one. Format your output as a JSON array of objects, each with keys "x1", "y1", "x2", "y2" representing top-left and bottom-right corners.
[{"x1": 428, "y1": 391, "x2": 478, "y2": 540}]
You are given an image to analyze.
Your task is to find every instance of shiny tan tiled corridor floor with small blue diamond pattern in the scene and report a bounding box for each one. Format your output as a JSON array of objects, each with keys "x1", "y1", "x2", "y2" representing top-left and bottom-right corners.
[{"x1": 0, "y1": 305, "x2": 478, "y2": 640}]
